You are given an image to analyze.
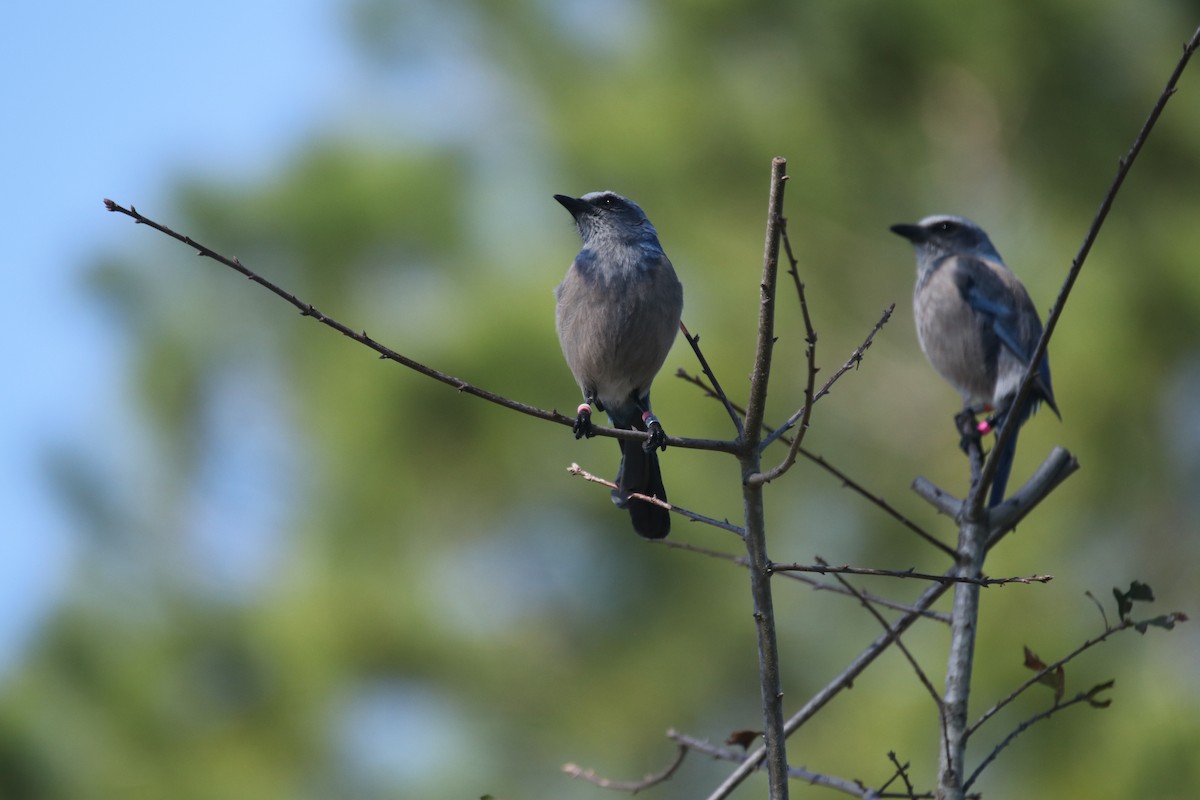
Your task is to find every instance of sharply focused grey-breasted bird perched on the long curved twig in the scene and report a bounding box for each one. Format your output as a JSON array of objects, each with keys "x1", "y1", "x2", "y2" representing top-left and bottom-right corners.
[{"x1": 554, "y1": 192, "x2": 683, "y2": 539}]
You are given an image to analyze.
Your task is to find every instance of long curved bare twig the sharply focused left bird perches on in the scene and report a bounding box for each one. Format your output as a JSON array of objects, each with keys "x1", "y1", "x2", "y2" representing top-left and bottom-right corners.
[{"x1": 104, "y1": 198, "x2": 736, "y2": 452}]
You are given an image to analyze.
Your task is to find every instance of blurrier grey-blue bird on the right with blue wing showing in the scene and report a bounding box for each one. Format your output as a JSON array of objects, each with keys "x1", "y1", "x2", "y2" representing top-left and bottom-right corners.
[{"x1": 892, "y1": 215, "x2": 1062, "y2": 506}]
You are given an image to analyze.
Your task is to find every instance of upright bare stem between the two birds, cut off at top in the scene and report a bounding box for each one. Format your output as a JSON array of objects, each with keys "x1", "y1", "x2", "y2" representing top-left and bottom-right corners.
[{"x1": 740, "y1": 158, "x2": 788, "y2": 800}]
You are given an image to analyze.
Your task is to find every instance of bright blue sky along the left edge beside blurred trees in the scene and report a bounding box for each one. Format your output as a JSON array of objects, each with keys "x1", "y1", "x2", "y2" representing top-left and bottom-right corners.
[{"x1": 0, "y1": 0, "x2": 355, "y2": 672}]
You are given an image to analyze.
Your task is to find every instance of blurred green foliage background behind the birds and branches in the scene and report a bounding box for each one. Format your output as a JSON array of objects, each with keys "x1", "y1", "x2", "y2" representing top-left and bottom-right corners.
[{"x1": 0, "y1": 0, "x2": 1200, "y2": 800}]
